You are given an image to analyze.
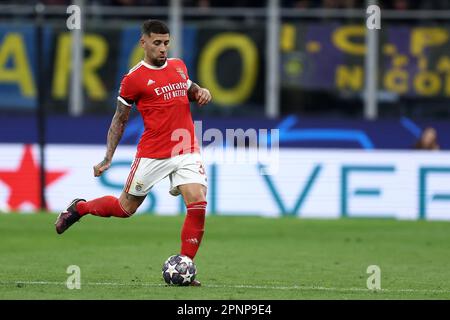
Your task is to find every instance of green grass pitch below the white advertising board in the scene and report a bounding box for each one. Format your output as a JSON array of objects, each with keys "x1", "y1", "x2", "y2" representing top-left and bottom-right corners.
[{"x1": 0, "y1": 214, "x2": 450, "y2": 300}]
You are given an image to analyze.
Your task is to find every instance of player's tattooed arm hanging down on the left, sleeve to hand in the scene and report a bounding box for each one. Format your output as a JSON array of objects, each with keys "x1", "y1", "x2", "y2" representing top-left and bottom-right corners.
[{"x1": 94, "y1": 101, "x2": 131, "y2": 177}]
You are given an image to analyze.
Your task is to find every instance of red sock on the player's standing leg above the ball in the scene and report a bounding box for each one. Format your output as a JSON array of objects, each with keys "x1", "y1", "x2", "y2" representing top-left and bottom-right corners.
[{"x1": 181, "y1": 201, "x2": 206, "y2": 259}]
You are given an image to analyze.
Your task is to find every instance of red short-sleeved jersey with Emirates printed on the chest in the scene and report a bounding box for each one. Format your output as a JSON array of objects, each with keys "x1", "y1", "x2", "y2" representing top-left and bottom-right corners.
[{"x1": 118, "y1": 59, "x2": 199, "y2": 159}]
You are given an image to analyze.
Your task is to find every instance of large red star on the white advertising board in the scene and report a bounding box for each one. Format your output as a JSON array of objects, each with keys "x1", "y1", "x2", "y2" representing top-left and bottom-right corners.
[{"x1": 0, "y1": 145, "x2": 67, "y2": 210}]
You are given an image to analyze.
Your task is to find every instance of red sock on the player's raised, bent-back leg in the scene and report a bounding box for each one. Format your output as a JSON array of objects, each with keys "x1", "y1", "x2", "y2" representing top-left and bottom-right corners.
[{"x1": 76, "y1": 196, "x2": 131, "y2": 218}]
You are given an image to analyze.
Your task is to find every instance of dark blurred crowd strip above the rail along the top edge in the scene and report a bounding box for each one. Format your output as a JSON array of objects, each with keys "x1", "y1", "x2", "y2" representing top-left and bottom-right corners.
[{"x1": 5, "y1": 0, "x2": 450, "y2": 10}]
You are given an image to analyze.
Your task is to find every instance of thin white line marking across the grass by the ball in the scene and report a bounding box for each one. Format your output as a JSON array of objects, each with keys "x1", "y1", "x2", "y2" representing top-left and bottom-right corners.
[{"x1": 0, "y1": 281, "x2": 450, "y2": 294}]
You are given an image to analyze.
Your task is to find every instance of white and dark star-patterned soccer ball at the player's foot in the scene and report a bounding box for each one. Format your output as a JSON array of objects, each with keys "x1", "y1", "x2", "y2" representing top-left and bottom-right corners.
[{"x1": 162, "y1": 254, "x2": 197, "y2": 286}]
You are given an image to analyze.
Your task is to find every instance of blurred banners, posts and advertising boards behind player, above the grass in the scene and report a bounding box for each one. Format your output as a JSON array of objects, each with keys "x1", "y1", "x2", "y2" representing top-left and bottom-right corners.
[{"x1": 0, "y1": 0, "x2": 450, "y2": 219}]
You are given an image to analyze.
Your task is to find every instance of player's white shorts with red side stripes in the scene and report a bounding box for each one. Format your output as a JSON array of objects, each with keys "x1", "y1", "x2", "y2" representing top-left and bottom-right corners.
[{"x1": 124, "y1": 153, "x2": 207, "y2": 196}]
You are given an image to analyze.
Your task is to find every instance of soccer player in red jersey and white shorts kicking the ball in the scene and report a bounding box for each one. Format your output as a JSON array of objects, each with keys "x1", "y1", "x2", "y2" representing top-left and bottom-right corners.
[{"x1": 55, "y1": 20, "x2": 211, "y2": 285}]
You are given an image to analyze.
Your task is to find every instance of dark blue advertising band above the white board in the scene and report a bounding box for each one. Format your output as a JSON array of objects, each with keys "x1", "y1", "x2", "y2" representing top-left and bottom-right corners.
[{"x1": 0, "y1": 114, "x2": 450, "y2": 150}]
